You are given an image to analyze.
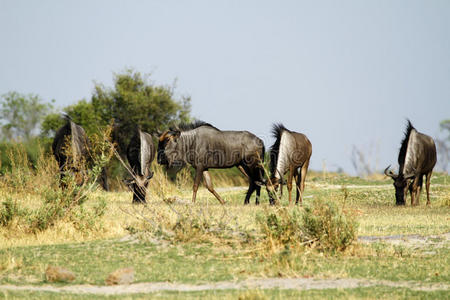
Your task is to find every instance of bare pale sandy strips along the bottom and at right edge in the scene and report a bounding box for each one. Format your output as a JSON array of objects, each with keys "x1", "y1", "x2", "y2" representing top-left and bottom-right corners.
[{"x1": 0, "y1": 233, "x2": 450, "y2": 295}]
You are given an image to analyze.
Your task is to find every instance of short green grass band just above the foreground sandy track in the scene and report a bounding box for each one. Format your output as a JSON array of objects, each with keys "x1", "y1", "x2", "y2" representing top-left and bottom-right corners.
[{"x1": 0, "y1": 232, "x2": 450, "y2": 285}]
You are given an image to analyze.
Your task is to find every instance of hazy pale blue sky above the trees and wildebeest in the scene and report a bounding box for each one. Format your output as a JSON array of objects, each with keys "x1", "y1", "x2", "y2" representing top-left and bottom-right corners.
[{"x1": 0, "y1": 0, "x2": 450, "y2": 172}]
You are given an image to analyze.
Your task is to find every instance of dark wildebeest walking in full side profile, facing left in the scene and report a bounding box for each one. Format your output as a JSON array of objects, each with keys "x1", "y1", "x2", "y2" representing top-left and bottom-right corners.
[{"x1": 158, "y1": 122, "x2": 265, "y2": 204}]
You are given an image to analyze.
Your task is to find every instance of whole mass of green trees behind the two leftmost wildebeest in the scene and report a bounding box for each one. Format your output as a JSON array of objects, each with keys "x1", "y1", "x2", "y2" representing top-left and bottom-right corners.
[{"x1": 43, "y1": 70, "x2": 191, "y2": 153}]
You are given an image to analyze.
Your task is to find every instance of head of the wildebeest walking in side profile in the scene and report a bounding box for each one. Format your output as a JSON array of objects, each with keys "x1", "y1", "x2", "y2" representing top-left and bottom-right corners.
[{"x1": 158, "y1": 130, "x2": 184, "y2": 167}]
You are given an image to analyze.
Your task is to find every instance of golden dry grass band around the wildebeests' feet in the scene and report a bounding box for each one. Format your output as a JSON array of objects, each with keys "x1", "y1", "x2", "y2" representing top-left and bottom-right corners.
[{"x1": 0, "y1": 139, "x2": 450, "y2": 253}]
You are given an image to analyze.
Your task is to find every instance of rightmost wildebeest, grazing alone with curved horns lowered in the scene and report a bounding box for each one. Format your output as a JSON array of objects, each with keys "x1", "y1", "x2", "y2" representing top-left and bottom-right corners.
[{"x1": 384, "y1": 120, "x2": 436, "y2": 205}]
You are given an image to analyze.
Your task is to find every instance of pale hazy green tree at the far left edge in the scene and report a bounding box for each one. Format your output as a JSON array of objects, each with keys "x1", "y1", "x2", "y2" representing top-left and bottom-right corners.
[{"x1": 0, "y1": 92, "x2": 54, "y2": 140}]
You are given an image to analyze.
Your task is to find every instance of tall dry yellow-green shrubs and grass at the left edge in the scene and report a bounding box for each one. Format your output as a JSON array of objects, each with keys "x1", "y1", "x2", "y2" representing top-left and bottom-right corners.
[{"x1": 0, "y1": 129, "x2": 112, "y2": 233}]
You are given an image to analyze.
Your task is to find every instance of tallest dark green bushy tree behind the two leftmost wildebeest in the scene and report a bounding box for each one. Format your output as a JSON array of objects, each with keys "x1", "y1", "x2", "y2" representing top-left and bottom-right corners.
[{"x1": 92, "y1": 70, "x2": 190, "y2": 153}]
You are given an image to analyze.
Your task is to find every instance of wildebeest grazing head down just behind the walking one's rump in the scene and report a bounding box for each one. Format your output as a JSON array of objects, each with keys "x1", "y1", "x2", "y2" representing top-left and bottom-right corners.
[{"x1": 266, "y1": 124, "x2": 312, "y2": 204}]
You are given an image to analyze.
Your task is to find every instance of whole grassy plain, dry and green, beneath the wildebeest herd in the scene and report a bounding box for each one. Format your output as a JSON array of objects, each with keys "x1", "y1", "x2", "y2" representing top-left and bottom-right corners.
[{"x1": 0, "y1": 157, "x2": 450, "y2": 299}]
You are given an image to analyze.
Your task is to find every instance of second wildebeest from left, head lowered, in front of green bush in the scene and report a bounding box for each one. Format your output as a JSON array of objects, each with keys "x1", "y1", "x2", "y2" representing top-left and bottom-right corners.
[{"x1": 127, "y1": 129, "x2": 156, "y2": 203}]
